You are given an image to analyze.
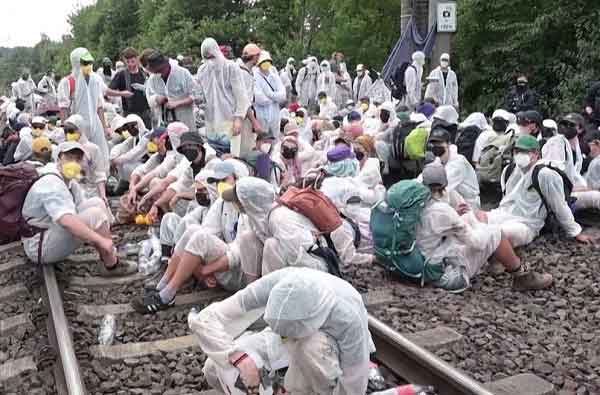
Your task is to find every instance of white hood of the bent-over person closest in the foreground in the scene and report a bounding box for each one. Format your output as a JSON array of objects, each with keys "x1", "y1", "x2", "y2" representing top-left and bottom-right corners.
[{"x1": 264, "y1": 273, "x2": 336, "y2": 339}]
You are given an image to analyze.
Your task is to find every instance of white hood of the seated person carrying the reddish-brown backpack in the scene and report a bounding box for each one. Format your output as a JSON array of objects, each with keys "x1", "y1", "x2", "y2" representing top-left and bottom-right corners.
[{"x1": 235, "y1": 177, "x2": 276, "y2": 242}]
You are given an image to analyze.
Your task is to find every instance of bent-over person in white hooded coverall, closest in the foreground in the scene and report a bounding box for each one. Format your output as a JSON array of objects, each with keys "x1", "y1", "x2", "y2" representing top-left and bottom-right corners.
[{"x1": 188, "y1": 268, "x2": 374, "y2": 395}]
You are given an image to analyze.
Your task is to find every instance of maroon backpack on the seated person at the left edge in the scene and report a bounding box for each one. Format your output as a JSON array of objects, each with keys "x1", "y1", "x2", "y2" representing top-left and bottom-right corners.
[{"x1": 0, "y1": 163, "x2": 52, "y2": 243}]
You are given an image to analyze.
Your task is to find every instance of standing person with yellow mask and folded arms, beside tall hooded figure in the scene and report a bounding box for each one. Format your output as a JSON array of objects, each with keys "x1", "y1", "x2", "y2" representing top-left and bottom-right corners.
[{"x1": 254, "y1": 51, "x2": 285, "y2": 139}]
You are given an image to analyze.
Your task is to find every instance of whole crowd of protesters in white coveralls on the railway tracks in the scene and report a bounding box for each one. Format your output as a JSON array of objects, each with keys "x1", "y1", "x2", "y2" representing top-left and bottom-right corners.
[{"x1": 0, "y1": 38, "x2": 600, "y2": 394}]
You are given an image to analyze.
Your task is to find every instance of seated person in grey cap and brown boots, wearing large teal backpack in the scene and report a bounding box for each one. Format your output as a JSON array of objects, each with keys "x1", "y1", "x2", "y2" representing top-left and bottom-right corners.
[{"x1": 416, "y1": 161, "x2": 552, "y2": 293}]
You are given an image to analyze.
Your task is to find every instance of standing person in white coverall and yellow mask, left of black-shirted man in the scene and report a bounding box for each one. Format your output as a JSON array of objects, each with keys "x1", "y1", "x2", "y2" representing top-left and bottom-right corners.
[{"x1": 71, "y1": 48, "x2": 110, "y2": 174}]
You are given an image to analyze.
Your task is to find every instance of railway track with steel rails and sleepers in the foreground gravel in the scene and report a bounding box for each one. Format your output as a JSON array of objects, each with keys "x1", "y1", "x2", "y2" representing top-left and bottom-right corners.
[{"x1": 0, "y1": 221, "x2": 553, "y2": 395}]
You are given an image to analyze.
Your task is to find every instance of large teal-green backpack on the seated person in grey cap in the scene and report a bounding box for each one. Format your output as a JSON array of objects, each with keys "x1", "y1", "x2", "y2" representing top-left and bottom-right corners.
[{"x1": 370, "y1": 180, "x2": 443, "y2": 283}]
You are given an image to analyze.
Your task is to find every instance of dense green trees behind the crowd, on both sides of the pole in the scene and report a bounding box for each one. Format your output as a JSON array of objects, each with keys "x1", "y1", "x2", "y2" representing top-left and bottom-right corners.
[{"x1": 0, "y1": 0, "x2": 600, "y2": 113}]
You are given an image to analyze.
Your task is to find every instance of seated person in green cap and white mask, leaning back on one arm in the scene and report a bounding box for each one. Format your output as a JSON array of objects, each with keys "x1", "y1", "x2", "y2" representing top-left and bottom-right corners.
[{"x1": 476, "y1": 135, "x2": 594, "y2": 248}]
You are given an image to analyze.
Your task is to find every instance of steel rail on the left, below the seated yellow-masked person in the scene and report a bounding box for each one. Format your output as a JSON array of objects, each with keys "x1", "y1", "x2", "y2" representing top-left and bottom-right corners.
[{"x1": 42, "y1": 265, "x2": 87, "y2": 395}]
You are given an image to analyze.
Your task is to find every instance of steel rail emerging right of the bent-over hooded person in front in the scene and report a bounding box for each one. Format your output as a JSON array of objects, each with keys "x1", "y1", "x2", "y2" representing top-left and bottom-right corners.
[{"x1": 369, "y1": 315, "x2": 494, "y2": 395}]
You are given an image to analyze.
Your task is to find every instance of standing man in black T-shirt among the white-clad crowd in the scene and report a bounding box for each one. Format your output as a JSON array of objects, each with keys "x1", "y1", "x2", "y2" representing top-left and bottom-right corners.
[{"x1": 107, "y1": 47, "x2": 152, "y2": 129}]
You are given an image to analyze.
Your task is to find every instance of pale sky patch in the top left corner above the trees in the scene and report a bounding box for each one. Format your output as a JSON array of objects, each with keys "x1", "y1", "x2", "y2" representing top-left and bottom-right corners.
[{"x1": 0, "y1": 0, "x2": 95, "y2": 47}]
